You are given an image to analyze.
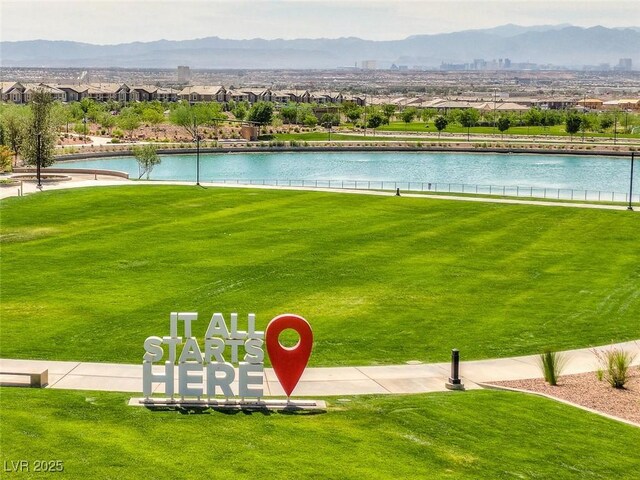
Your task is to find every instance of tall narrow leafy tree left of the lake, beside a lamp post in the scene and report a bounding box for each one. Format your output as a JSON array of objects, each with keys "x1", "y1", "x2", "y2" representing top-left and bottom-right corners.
[{"x1": 21, "y1": 90, "x2": 57, "y2": 167}]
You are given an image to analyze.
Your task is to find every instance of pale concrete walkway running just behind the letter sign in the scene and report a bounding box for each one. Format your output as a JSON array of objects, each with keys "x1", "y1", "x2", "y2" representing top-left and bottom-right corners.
[{"x1": 0, "y1": 340, "x2": 640, "y2": 397}]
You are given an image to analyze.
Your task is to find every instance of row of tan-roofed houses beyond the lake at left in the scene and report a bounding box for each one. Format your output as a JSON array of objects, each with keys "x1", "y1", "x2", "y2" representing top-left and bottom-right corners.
[{"x1": 0, "y1": 82, "x2": 365, "y2": 105}]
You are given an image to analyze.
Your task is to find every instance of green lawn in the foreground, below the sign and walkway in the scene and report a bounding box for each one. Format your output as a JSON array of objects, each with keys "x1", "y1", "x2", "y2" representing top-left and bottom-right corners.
[{"x1": 0, "y1": 388, "x2": 640, "y2": 479}]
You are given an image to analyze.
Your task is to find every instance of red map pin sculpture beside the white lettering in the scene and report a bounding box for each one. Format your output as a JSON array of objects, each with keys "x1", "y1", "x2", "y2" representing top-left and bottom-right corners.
[{"x1": 264, "y1": 313, "x2": 313, "y2": 397}]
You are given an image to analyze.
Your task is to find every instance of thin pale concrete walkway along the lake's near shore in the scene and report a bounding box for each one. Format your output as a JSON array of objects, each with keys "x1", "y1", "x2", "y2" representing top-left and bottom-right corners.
[{"x1": 0, "y1": 174, "x2": 640, "y2": 213}]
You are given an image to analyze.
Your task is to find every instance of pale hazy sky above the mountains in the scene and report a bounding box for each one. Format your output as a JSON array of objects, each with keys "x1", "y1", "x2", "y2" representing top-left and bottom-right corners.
[{"x1": 0, "y1": 0, "x2": 640, "y2": 44}]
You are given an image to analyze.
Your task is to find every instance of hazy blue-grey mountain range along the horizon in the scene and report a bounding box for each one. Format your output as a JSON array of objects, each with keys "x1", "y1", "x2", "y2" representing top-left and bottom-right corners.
[{"x1": 0, "y1": 24, "x2": 640, "y2": 69}]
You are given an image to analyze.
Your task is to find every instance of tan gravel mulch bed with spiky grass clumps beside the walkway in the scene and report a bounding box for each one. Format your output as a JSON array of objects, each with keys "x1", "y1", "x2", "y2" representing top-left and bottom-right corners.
[{"x1": 492, "y1": 366, "x2": 640, "y2": 424}]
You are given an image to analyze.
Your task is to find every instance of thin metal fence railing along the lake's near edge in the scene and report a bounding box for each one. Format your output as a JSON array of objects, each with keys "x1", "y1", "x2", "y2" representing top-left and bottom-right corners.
[{"x1": 209, "y1": 179, "x2": 640, "y2": 203}]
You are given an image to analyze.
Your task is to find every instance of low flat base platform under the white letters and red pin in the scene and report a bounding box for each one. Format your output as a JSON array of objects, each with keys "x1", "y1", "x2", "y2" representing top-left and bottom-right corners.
[{"x1": 129, "y1": 397, "x2": 327, "y2": 411}]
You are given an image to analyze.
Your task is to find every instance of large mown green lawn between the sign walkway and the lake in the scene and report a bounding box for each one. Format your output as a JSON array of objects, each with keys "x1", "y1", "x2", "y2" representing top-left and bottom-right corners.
[{"x1": 0, "y1": 186, "x2": 640, "y2": 366}]
